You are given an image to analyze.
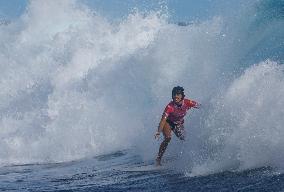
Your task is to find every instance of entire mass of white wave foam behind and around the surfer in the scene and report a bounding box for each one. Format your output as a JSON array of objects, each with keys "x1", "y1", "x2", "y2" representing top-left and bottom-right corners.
[{"x1": 0, "y1": 0, "x2": 284, "y2": 174}]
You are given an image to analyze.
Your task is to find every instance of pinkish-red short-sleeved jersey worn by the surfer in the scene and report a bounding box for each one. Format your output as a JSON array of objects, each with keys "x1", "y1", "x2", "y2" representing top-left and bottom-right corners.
[{"x1": 164, "y1": 99, "x2": 198, "y2": 124}]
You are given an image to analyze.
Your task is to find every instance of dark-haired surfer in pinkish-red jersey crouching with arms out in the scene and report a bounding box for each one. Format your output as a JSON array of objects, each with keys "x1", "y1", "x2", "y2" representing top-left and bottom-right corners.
[{"x1": 155, "y1": 86, "x2": 200, "y2": 165}]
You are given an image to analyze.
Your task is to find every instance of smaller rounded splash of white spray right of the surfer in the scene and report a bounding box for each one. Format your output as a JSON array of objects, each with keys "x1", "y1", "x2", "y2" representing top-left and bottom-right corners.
[{"x1": 186, "y1": 60, "x2": 284, "y2": 174}]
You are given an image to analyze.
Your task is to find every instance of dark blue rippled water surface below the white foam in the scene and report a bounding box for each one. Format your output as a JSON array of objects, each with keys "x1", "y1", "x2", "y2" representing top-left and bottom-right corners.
[{"x1": 0, "y1": 150, "x2": 284, "y2": 191}]
